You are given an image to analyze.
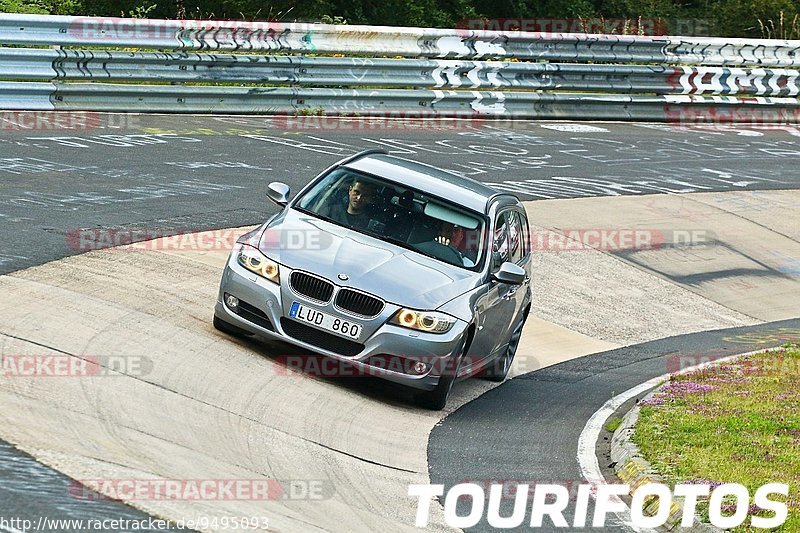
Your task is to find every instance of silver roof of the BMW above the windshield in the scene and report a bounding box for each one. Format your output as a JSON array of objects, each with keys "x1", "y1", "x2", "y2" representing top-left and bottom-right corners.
[{"x1": 344, "y1": 154, "x2": 506, "y2": 213}]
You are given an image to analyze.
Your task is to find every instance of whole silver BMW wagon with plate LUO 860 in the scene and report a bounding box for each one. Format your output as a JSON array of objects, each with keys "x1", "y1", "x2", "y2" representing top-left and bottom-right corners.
[{"x1": 214, "y1": 150, "x2": 531, "y2": 409}]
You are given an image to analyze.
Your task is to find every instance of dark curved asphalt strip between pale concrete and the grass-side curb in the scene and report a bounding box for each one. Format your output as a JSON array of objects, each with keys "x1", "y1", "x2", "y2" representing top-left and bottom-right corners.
[{"x1": 428, "y1": 319, "x2": 800, "y2": 531}]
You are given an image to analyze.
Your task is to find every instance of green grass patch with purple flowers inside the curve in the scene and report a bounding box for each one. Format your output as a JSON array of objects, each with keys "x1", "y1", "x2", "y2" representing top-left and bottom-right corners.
[{"x1": 633, "y1": 344, "x2": 800, "y2": 531}]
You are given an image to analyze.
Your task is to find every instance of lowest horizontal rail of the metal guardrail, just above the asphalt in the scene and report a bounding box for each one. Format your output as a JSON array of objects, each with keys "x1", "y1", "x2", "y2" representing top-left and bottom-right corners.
[{"x1": 0, "y1": 83, "x2": 800, "y2": 122}]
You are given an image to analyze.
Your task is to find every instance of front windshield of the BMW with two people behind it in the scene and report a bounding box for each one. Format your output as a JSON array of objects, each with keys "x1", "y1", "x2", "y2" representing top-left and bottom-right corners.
[{"x1": 294, "y1": 168, "x2": 484, "y2": 270}]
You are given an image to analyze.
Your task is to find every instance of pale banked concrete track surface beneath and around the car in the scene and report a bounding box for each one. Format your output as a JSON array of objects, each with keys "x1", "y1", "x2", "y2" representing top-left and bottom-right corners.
[{"x1": 0, "y1": 191, "x2": 800, "y2": 531}]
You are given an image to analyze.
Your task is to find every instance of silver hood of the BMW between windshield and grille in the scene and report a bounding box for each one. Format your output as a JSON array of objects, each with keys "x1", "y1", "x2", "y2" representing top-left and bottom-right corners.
[{"x1": 258, "y1": 209, "x2": 481, "y2": 309}]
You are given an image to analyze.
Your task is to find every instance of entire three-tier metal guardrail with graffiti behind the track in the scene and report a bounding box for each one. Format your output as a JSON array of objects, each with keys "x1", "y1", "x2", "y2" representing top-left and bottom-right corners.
[{"x1": 0, "y1": 14, "x2": 800, "y2": 123}]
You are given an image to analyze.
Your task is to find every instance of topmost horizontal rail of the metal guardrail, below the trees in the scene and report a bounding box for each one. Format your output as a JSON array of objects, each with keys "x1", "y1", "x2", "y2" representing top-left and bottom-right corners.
[{"x1": 0, "y1": 14, "x2": 800, "y2": 67}]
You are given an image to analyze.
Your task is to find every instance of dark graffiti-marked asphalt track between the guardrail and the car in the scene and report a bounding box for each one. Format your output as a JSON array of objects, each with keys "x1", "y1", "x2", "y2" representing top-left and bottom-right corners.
[{"x1": 0, "y1": 113, "x2": 800, "y2": 274}]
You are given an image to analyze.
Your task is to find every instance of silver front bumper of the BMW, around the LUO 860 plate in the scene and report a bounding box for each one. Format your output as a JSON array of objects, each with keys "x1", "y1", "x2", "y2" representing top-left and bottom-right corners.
[{"x1": 214, "y1": 250, "x2": 467, "y2": 390}]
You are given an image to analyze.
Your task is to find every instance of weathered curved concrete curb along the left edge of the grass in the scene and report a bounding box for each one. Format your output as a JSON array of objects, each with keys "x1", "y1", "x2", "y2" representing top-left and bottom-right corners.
[{"x1": 611, "y1": 388, "x2": 723, "y2": 533}]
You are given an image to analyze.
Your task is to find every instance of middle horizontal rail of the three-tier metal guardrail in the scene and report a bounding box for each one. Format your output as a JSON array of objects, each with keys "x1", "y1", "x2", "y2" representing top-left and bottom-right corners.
[{"x1": 0, "y1": 48, "x2": 800, "y2": 96}]
